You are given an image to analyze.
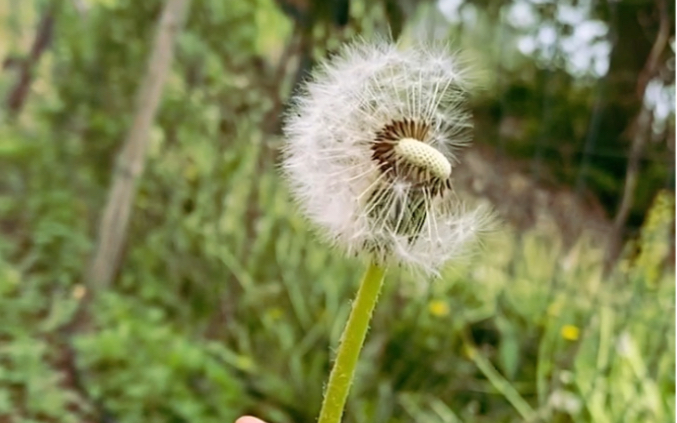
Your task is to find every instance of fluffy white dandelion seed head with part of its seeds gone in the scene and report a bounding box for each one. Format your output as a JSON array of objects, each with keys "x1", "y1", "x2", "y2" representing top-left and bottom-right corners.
[{"x1": 283, "y1": 41, "x2": 487, "y2": 273}]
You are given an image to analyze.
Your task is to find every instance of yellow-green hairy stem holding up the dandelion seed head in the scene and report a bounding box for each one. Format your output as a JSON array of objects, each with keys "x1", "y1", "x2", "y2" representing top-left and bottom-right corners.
[{"x1": 318, "y1": 263, "x2": 385, "y2": 423}]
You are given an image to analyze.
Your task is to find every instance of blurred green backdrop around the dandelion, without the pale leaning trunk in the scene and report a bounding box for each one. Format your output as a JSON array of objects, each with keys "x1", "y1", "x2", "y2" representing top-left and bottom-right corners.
[{"x1": 0, "y1": 0, "x2": 675, "y2": 423}]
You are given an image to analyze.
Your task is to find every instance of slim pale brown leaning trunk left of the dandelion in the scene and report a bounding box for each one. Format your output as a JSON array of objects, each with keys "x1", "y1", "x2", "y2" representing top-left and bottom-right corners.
[{"x1": 86, "y1": 0, "x2": 190, "y2": 291}]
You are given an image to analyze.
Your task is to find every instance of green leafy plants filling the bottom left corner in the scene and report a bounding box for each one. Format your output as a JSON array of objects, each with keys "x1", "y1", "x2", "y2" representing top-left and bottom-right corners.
[{"x1": 0, "y1": 258, "x2": 83, "y2": 422}]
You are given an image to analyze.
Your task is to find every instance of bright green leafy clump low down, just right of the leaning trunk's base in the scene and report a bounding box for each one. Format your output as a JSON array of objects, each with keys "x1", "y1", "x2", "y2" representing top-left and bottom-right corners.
[{"x1": 76, "y1": 296, "x2": 247, "y2": 423}]
